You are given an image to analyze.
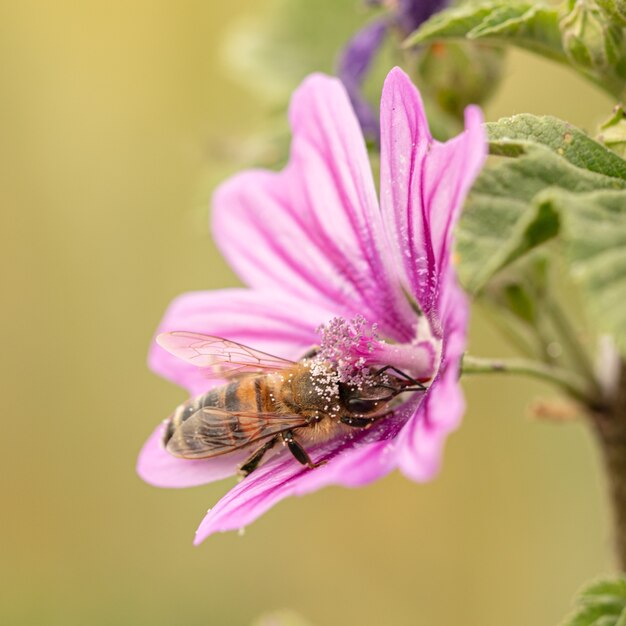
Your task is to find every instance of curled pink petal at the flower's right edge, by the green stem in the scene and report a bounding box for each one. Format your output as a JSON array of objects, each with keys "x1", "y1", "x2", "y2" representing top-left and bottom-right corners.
[{"x1": 395, "y1": 273, "x2": 469, "y2": 481}]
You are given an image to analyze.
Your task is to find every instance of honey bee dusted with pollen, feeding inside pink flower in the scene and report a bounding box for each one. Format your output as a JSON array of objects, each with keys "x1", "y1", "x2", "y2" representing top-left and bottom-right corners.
[{"x1": 157, "y1": 331, "x2": 426, "y2": 476}]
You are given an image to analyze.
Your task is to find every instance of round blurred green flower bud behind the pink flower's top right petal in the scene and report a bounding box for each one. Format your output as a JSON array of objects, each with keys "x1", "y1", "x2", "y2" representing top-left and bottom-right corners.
[{"x1": 417, "y1": 42, "x2": 503, "y2": 119}]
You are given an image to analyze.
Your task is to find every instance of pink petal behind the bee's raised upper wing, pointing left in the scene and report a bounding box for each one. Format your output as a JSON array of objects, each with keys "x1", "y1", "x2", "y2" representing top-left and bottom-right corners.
[{"x1": 149, "y1": 289, "x2": 333, "y2": 395}]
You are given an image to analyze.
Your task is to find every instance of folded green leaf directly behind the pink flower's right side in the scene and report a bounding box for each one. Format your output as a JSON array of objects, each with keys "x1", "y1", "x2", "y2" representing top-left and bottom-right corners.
[{"x1": 458, "y1": 115, "x2": 626, "y2": 292}]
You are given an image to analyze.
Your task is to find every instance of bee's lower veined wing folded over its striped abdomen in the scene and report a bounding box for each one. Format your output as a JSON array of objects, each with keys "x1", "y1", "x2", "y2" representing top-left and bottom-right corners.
[{"x1": 166, "y1": 407, "x2": 307, "y2": 459}]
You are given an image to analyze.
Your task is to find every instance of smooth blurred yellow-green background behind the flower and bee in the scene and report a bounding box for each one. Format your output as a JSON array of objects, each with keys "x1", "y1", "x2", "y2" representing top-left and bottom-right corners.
[{"x1": 0, "y1": 0, "x2": 612, "y2": 626}]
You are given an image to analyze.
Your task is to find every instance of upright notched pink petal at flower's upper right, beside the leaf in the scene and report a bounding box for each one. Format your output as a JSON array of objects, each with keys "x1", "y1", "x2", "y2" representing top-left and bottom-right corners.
[{"x1": 381, "y1": 68, "x2": 487, "y2": 322}]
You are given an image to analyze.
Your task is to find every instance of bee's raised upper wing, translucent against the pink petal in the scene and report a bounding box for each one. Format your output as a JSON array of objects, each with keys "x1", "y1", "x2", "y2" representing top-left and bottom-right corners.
[{"x1": 156, "y1": 331, "x2": 294, "y2": 378}]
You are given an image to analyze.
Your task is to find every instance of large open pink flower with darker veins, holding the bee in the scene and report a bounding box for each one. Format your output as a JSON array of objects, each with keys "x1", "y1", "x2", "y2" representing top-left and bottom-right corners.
[{"x1": 138, "y1": 68, "x2": 486, "y2": 543}]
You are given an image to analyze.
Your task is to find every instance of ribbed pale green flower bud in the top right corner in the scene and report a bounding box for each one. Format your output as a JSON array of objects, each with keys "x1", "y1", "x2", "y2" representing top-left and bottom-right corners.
[{"x1": 560, "y1": 0, "x2": 624, "y2": 74}]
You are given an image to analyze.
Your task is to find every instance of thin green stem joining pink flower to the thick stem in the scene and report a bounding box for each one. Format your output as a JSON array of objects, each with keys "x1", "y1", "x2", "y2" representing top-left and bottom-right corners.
[{"x1": 461, "y1": 354, "x2": 594, "y2": 406}]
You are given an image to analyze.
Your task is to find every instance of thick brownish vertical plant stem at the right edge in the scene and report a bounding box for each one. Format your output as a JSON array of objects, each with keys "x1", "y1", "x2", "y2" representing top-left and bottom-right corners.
[{"x1": 591, "y1": 361, "x2": 626, "y2": 571}]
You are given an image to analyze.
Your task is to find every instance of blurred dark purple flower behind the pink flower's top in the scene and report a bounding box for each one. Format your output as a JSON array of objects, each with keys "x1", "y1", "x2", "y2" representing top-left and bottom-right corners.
[{"x1": 337, "y1": 0, "x2": 449, "y2": 140}]
